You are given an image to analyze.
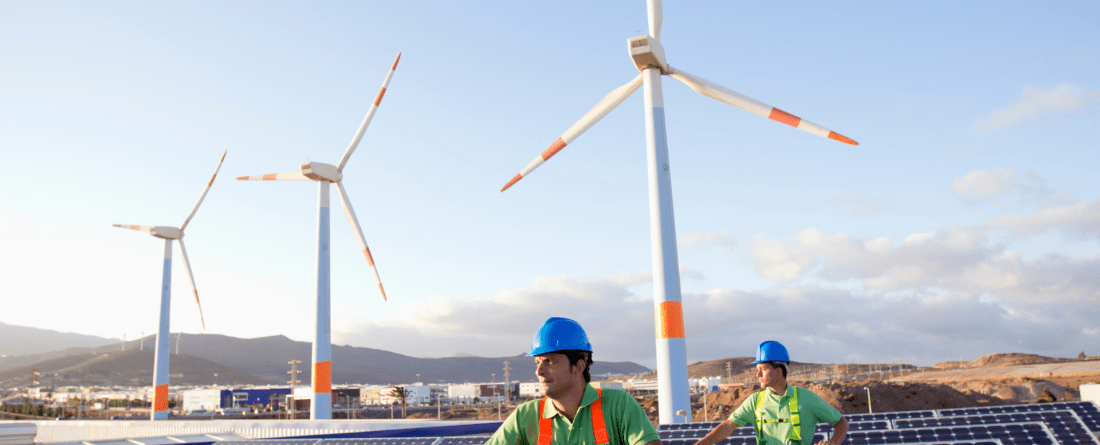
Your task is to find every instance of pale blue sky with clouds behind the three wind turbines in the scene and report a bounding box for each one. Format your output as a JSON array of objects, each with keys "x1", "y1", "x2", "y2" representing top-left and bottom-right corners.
[{"x1": 0, "y1": 0, "x2": 1100, "y2": 366}]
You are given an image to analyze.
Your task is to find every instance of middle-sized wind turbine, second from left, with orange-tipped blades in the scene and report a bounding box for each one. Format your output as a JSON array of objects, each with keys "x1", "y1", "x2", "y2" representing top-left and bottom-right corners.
[{"x1": 237, "y1": 53, "x2": 402, "y2": 419}]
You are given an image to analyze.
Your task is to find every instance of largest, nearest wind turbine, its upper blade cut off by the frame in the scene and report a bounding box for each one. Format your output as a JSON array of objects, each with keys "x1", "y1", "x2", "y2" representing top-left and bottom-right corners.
[{"x1": 501, "y1": 0, "x2": 859, "y2": 423}]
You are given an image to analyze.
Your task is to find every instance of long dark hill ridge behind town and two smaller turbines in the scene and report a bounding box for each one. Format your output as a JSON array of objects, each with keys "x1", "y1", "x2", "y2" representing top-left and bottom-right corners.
[{"x1": 0, "y1": 334, "x2": 650, "y2": 385}]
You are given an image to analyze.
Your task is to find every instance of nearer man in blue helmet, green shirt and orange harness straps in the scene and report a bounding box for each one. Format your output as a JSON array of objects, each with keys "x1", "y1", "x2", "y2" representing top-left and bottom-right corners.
[{"x1": 485, "y1": 318, "x2": 661, "y2": 445}]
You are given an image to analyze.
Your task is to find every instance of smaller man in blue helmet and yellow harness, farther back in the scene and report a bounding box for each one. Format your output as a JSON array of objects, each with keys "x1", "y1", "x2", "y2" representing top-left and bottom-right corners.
[{"x1": 695, "y1": 341, "x2": 848, "y2": 445}]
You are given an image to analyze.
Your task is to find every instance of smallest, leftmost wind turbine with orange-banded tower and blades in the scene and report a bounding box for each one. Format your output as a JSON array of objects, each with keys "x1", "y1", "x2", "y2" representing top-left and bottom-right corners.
[{"x1": 114, "y1": 151, "x2": 228, "y2": 420}]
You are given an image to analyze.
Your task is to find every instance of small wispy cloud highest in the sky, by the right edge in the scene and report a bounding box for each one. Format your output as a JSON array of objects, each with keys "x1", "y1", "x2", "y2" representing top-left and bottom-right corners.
[{"x1": 972, "y1": 82, "x2": 1100, "y2": 132}]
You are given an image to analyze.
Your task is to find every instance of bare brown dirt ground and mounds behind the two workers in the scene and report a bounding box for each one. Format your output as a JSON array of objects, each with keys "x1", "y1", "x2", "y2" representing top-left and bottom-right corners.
[{"x1": 426, "y1": 356, "x2": 1100, "y2": 423}]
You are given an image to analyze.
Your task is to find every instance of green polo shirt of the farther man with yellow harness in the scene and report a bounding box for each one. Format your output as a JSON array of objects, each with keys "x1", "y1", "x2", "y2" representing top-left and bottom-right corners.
[{"x1": 729, "y1": 385, "x2": 840, "y2": 445}]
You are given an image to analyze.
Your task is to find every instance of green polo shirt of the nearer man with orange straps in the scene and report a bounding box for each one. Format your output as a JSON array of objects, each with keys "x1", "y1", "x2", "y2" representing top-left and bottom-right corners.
[{"x1": 485, "y1": 385, "x2": 660, "y2": 445}]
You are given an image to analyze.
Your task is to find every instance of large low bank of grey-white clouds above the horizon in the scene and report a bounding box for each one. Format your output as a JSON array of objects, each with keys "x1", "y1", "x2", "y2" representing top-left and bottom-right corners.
[{"x1": 334, "y1": 201, "x2": 1100, "y2": 367}]
